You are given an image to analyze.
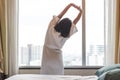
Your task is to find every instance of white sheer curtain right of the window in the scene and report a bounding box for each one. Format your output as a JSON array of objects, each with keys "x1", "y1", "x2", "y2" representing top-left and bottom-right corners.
[{"x1": 105, "y1": 0, "x2": 116, "y2": 65}]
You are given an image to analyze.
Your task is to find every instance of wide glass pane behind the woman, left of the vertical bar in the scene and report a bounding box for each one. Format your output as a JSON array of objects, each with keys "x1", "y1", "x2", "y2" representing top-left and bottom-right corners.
[{"x1": 19, "y1": 0, "x2": 82, "y2": 66}]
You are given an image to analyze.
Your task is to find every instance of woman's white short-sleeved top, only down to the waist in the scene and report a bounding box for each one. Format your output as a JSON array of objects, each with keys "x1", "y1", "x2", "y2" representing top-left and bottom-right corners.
[{"x1": 45, "y1": 16, "x2": 77, "y2": 49}]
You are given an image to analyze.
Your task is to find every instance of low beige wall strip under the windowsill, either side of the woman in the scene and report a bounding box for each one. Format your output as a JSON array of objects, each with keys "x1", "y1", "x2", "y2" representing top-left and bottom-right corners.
[{"x1": 19, "y1": 69, "x2": 97, "y2": 76}]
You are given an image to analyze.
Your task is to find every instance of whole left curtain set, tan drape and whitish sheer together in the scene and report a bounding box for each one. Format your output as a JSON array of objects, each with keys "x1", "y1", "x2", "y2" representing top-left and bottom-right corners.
[{"x1": 0, "y1": 0, "x2": 18, "y2": 76}]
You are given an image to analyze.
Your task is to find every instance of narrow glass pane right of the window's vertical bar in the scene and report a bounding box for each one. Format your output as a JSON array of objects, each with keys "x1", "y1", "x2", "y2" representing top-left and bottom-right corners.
[{"x1": 86, "y1": 0, "x2": 104, "y2": 66}]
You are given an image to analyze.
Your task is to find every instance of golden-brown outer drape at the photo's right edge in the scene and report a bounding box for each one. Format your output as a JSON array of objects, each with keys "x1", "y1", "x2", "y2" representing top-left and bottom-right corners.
[{"x1": 114, "y1": 0, "x2": 120, "y2": 64}]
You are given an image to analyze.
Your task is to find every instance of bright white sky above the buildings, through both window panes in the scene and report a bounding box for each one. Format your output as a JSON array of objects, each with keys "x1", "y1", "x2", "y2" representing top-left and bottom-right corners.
[{"x1": 19, "y1": 0, "x2": 104, "y2": 46}]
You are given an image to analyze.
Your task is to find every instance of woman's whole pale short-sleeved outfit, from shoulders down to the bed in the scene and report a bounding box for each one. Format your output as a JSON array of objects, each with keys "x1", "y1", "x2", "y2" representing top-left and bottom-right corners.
[{"x1": 41, "y1": 16, "x2": 77, "y2": 75}]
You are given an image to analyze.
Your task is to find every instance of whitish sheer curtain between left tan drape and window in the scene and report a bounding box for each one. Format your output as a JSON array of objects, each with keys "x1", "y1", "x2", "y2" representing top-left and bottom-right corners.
[{"x1": 6, "y1": 0, "x2": 18, "y2": 76}]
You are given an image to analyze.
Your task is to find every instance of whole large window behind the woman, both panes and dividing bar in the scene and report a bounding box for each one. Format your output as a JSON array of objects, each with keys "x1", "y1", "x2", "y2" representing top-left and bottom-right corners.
[{"x1": 19, "y1": 0, "x2": 105, "y2": 67}]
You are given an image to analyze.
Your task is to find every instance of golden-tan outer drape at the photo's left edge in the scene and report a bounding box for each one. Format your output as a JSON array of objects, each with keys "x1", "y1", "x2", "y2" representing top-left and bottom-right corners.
[{"x1": 0, "y1": 0, "x2": 7, "y2": 74}]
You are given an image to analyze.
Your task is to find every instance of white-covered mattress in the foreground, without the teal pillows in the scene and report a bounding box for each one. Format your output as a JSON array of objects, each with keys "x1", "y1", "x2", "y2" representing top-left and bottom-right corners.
[{"x1": 5, "y1": 74, "x2": 98, "y2": 80}]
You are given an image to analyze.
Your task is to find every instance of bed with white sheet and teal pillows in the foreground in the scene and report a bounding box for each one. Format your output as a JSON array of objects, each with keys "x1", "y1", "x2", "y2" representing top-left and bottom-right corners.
[{"x1": 5, "y1": 64, "x2": 120, "y2": 80}]
